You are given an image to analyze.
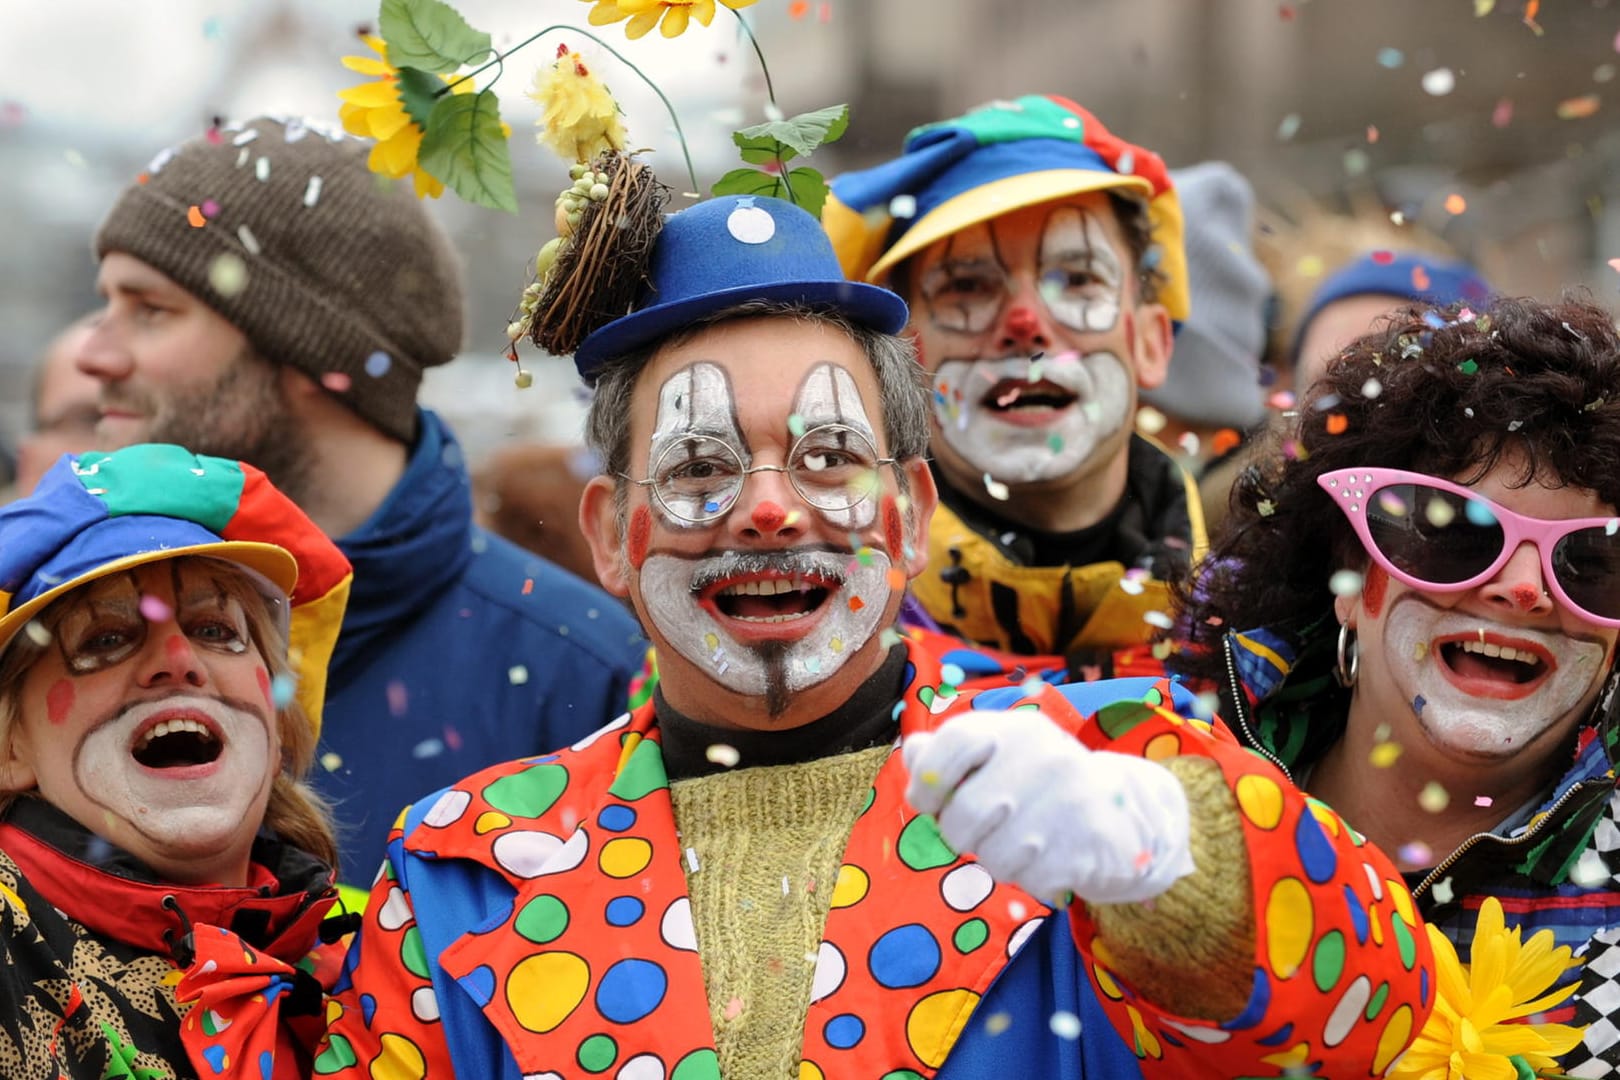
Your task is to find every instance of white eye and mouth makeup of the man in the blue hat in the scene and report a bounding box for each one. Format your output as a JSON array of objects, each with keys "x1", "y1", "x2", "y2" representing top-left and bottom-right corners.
[{"x1": 640, "y1": 363, "x2": 893, "y2": 716}]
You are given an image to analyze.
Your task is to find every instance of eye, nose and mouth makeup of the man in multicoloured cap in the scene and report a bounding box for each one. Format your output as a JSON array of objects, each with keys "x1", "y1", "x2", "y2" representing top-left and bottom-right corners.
[{"x1": 917, "y1": 206, "x2": 1136, "y2": 483}]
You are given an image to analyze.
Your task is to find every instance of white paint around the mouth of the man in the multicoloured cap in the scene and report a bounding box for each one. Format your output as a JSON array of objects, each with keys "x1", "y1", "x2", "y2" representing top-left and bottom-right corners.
[{"x1": 933, "y1": 353, "x2": 1131, "y2": 484}]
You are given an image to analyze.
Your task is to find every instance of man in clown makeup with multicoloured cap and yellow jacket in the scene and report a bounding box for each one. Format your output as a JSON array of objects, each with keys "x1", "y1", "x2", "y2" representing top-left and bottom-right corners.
[{"x1": 823, "y1": 96, "x2": 1204, "y2": 663}]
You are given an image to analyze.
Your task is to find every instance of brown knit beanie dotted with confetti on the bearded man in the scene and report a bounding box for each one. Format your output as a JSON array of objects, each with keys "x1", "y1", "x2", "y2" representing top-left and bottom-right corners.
[{"x1": 96, "y1": 117, "x2": 462, "y2": 444}]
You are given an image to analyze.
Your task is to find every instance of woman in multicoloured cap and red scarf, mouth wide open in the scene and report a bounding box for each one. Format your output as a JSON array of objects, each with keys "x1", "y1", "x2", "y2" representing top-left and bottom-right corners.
[{"x1": 0, "y1": 445, "x2": 350, "y2": 1080}]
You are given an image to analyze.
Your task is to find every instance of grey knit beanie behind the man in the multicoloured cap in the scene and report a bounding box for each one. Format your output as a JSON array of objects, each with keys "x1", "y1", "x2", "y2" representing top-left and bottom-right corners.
[{"x1": 1142, "y1": 162, "x2": 1272, "y2": 431}]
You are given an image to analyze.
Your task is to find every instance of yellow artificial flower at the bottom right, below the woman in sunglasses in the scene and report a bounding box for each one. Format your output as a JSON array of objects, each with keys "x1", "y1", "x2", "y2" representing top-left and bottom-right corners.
[{"x1": 1388, "y1": 897, "x2": 1584, "y2": 1080}]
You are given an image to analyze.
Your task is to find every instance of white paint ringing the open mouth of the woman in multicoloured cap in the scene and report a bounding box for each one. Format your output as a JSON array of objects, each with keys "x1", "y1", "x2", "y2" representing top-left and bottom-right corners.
[{"x1": 75, "y1": 696, "x2": 279, "y2": 858}]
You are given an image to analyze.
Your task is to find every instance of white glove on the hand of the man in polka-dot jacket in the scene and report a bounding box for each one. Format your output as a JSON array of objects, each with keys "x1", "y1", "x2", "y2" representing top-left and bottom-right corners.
[{"x1": 901, "y1": 709, "x2": 1192, "y2": 904}]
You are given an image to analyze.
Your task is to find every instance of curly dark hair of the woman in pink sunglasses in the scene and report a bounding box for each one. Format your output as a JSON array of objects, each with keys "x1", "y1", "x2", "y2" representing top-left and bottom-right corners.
[{"x1": 1175, "y1": 286, "x2": 1620, "y2": 677}]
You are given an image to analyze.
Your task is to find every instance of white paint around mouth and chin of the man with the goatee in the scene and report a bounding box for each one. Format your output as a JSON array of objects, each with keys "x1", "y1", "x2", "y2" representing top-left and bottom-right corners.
[{"x1": 640, "y1": 549, "x2": 889, "y2": 698}]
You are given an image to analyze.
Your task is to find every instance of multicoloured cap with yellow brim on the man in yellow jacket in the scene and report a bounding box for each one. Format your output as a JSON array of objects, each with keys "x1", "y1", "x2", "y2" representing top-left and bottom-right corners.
[{"x1": 821, "y1": 94, "x2": 1187, "y2": 324}]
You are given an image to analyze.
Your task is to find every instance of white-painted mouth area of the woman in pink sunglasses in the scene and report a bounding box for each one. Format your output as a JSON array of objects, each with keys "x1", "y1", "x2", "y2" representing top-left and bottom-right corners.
[{"x1": 1383, "y1": 591, "x2": 1609, "y2": 758}]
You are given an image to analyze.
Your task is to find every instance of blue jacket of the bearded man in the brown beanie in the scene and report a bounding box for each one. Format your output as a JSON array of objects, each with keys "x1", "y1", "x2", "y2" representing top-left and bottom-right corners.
[{"x1": 313, "y1": 410, "x2": 646, "y2": 886}]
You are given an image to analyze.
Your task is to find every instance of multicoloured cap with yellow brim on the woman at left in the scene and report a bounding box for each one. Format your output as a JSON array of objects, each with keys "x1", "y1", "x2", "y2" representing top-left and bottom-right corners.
[{"x1": 0, "y1": 444, "x2": 353, "y2": 735}]
